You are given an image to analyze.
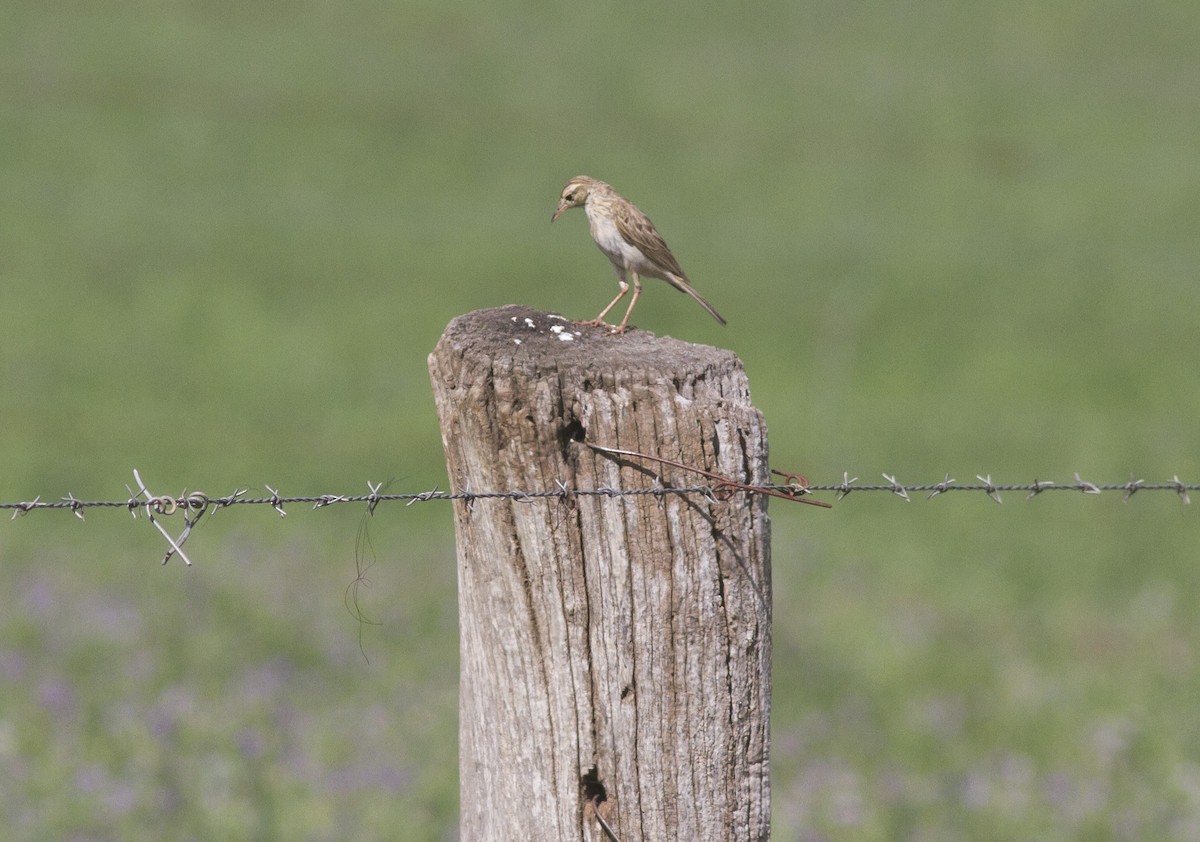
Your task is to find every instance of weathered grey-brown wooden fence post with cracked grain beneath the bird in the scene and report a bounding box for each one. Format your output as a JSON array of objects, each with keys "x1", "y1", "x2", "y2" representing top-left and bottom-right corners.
[{"x1": 430, "y1": 306, "x2": 770, "y2": 842}]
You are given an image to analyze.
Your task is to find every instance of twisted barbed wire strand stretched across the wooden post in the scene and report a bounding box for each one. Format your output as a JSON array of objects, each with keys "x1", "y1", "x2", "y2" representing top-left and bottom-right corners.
[{"x1": 0, "y1": 465, "x2": 1200, "y2": 565}]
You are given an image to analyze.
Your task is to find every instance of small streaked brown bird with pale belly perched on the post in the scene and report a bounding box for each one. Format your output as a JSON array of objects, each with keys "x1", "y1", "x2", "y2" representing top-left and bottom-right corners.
[{"x1": 550, "y1": 175, "x2": 727, "y2": 333}]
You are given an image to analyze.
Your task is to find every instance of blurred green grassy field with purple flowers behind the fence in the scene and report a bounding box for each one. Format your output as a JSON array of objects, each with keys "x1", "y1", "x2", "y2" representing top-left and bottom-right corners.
[{"x1": 0, "y1": 0, "x2": 1200, "y2": 841}]
